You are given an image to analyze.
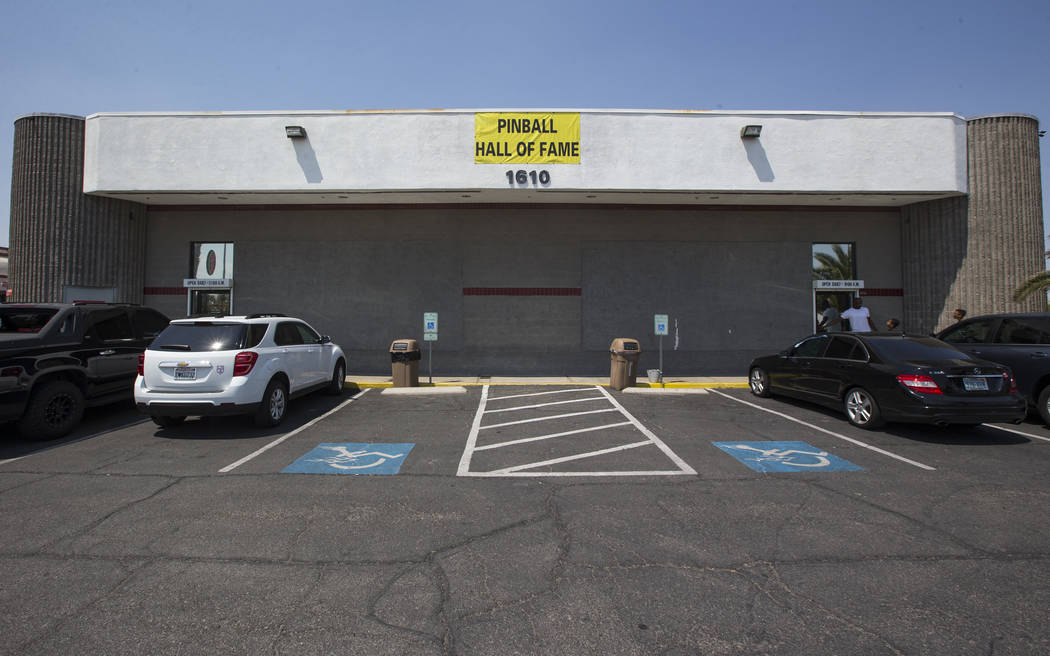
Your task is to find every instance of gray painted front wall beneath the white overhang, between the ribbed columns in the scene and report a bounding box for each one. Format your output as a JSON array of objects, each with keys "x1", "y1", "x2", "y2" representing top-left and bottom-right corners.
[{"x1": 146, "y1": 207, "x2": 901, "y2": 376}]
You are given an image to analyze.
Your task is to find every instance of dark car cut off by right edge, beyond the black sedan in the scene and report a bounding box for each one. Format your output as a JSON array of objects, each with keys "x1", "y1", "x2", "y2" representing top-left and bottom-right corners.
[{"x1": 938, "y1": 313, "x2": 1050, "y2": 425}]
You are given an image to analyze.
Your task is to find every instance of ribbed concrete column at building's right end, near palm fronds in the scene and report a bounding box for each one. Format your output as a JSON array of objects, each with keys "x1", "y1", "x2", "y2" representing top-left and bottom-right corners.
[{"x1": 901, "y1": 111, "x2": 1047, "y2": 333}]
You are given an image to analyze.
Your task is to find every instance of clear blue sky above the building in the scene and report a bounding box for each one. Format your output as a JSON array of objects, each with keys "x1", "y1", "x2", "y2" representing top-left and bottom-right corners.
[{"x1": 0, "y1": 0, "x2": 1050, "y2": 246}]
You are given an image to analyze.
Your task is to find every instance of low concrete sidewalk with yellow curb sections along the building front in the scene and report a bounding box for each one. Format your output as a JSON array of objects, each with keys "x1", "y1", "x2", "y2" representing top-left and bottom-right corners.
[{"x1": 347, "y1": 374, "x2": 748, "y2": 389}]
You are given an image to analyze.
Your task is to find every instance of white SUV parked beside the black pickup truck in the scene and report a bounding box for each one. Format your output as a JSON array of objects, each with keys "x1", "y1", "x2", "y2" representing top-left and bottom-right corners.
[{"x1": 134, "y1": 314, "x2": 347, "y2": 427}]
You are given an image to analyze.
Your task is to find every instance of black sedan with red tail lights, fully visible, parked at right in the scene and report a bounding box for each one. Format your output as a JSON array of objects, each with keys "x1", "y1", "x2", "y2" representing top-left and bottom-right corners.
[{"x1": 749, "y1": 333, "x2": 1026, "y2": 428}]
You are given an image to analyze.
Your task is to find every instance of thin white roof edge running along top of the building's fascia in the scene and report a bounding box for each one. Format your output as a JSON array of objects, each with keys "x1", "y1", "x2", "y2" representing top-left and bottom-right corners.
[{"x1": 79, "y1": 107, "x2": 965, "y2": 121}]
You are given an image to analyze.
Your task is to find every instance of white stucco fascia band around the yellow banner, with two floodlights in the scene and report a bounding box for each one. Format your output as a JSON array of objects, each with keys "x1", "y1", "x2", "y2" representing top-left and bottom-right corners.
[{"x1": 84, "y1": 110, "x2": 966, "y2": 195}]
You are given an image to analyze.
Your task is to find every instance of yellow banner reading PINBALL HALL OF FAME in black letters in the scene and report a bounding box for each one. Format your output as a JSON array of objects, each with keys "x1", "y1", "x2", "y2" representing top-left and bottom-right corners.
[{"x1": 474, "y1": 111, "x2": 580, "y2": 164}]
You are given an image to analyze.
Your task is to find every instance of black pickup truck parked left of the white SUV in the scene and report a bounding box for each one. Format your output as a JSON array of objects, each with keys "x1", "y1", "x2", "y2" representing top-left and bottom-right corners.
[{"x1": 0, "y1": 302, "x2": 168, "y2": 440}]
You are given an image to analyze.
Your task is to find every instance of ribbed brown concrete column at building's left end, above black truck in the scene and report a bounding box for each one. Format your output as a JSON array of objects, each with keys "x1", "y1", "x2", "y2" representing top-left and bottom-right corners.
[{"x1": 9, "y1": 114, "x2": 146, "y2": 303}]
